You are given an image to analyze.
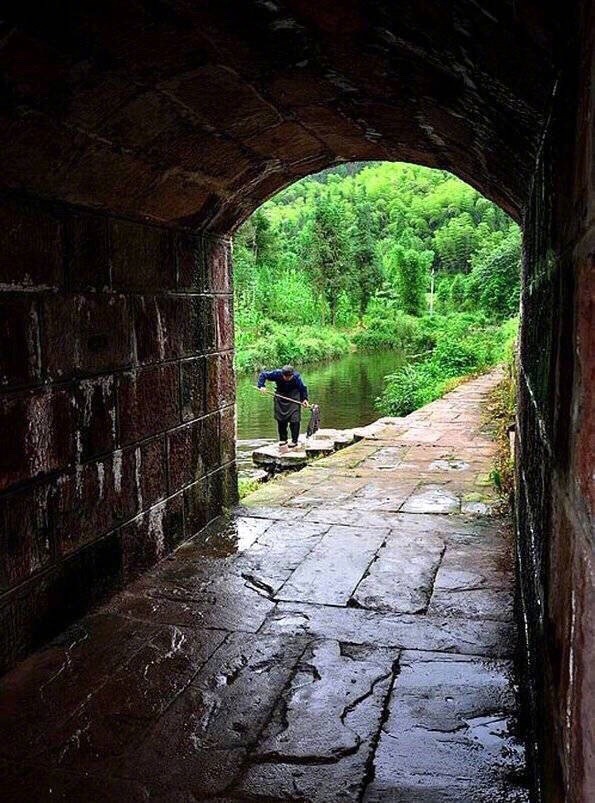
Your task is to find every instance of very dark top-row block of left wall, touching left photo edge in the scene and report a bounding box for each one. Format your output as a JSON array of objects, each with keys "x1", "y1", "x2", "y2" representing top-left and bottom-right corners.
[{"x1": 0, "y1": 202, "x2": 64, "y2": 290}]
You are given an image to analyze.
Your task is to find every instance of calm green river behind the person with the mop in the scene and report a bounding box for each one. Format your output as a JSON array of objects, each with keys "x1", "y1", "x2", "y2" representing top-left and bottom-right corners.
[{"x1": 237, "y1": 351, "x2": 404, "y2": 475}]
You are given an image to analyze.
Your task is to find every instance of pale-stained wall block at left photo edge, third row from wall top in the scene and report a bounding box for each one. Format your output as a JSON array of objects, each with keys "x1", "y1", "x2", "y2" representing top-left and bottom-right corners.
[{"x1": 0, "y1": 390, "x2": 75, "y2": 490}]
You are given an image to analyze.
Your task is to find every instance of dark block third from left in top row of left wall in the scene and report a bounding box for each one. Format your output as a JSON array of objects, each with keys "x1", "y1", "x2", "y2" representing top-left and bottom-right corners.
[{"x1": 110, "y1": 220, "x2": 176, "y2": 292}]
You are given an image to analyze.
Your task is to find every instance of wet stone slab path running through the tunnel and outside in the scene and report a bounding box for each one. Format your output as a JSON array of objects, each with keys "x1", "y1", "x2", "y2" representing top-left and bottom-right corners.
[{"x1": 0, "y1": 373, "x2": 529, "y2": 803}]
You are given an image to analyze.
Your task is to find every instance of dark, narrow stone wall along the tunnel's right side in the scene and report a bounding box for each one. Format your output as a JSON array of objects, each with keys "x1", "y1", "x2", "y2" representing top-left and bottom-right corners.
[{"x1": 516, "y1": 7, "x2": 595, "y2": 803}]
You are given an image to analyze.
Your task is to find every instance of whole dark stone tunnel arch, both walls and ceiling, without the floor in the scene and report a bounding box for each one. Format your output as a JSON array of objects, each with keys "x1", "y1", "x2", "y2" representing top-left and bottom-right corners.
[{"x1": 0, "y1": 0, "x2": 595, "y2": 803}]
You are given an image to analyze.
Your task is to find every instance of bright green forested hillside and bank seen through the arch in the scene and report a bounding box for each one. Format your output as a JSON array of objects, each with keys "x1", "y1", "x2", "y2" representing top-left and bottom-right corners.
[{"x1": 234, "y1": 162, "x2": 520, "y2": 415}]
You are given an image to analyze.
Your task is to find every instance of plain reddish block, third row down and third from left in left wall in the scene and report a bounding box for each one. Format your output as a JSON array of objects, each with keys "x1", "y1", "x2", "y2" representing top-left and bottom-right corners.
[{"x1": 117, "y1": 364, "x2": 180, "y2": 445}]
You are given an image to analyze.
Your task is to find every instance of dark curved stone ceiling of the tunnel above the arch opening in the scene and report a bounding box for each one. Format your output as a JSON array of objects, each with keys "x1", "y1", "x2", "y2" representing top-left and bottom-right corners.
[{"x1": 0, "y1": 0, "x2": 555, "y2": 231}]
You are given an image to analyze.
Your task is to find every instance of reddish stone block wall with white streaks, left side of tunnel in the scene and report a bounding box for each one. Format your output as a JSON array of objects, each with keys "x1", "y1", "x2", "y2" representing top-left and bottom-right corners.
[{"x1": 0, "y1": 196, "x2": 236, "y2": 671}]
